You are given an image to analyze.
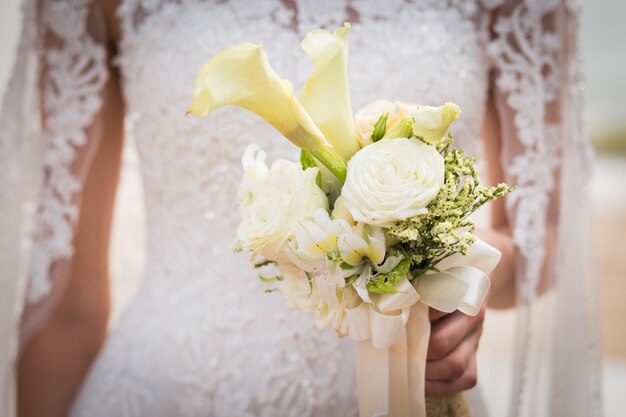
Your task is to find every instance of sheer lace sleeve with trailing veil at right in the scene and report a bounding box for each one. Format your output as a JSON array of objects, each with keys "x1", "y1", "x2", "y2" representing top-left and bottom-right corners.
[{"x1": 490, "y1": 0, "x2": 601, "y2": 416}]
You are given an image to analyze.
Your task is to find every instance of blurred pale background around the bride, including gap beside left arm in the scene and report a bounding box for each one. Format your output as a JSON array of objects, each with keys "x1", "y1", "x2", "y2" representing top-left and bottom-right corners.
[{"x1": 0, "y1": 0, "x2": 626, "y2": 417}]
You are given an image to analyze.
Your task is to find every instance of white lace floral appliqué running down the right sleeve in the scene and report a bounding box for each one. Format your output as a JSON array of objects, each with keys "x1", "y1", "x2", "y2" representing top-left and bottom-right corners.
[{"x1": 489, "y1": 1, "x2": 561, "y2": 300}]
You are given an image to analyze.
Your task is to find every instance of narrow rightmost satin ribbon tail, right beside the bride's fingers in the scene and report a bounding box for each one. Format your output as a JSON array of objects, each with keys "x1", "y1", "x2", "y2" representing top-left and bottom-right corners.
[{"x1": 406, "y1": 303, "x2": 430, "y2": 417}]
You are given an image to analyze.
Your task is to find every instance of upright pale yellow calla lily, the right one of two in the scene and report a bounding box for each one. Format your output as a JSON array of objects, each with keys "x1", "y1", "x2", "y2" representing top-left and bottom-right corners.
[{"x1": 298, "y1": 23, "x2": 360, "y2": 160}]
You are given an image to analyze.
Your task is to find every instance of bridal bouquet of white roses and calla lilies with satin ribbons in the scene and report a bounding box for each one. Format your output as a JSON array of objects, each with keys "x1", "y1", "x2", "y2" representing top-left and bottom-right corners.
[{"x1": 189, "y1": 24, "x2": 511, "y2": 417}]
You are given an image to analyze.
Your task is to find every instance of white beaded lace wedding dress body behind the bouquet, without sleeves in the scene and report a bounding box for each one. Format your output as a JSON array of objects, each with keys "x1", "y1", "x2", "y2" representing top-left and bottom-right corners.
[{"x1": 68, "y1": 0, "x2": 488, "y2": 417}]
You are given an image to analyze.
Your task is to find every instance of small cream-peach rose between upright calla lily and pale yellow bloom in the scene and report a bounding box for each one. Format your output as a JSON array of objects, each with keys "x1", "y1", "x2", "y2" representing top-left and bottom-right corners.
[{"x1": 354, "y1": 100, "x2": 417, "y2": 147}]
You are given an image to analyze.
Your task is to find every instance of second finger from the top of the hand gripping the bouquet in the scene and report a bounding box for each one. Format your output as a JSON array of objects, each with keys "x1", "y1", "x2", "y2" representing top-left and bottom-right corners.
[{"x1": 425, "y1": 328, "x2": 482, "y2": 381}]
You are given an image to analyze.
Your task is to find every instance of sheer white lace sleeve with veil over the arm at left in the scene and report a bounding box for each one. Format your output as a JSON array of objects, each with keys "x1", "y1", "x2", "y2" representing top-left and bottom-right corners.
[{"x1": 0, "y1": 0, "x2": 108, "y2": 416}]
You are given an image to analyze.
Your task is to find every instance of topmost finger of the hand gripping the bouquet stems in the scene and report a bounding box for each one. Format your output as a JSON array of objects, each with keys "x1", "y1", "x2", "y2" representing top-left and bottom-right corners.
[{"x1": 426, "y1": 310, "x2": 484, "y2": 360}]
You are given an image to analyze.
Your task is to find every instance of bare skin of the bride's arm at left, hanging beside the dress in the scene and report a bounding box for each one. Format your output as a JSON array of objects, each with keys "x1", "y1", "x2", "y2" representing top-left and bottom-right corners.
[{"x1": 18, "y1": 7, "x2": 123, "y2": 417}]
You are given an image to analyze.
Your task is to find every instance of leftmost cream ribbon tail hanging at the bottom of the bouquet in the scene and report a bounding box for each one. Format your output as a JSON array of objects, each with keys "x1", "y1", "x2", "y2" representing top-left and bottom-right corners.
[{"x1": 356, "y1": 340, "x2": 389, "y2": 417}]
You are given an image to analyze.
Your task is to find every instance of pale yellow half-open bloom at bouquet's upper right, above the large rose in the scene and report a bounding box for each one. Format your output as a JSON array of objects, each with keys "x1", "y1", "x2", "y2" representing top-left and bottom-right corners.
[{"x1": 412, "y1": 102, "x2": 461, "y2": 146}]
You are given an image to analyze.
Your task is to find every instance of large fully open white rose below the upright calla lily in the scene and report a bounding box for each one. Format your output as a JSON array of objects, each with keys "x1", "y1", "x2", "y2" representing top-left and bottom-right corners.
[{"x1": 341, "y1": 138, "x2": 444, "y2": 227}]
